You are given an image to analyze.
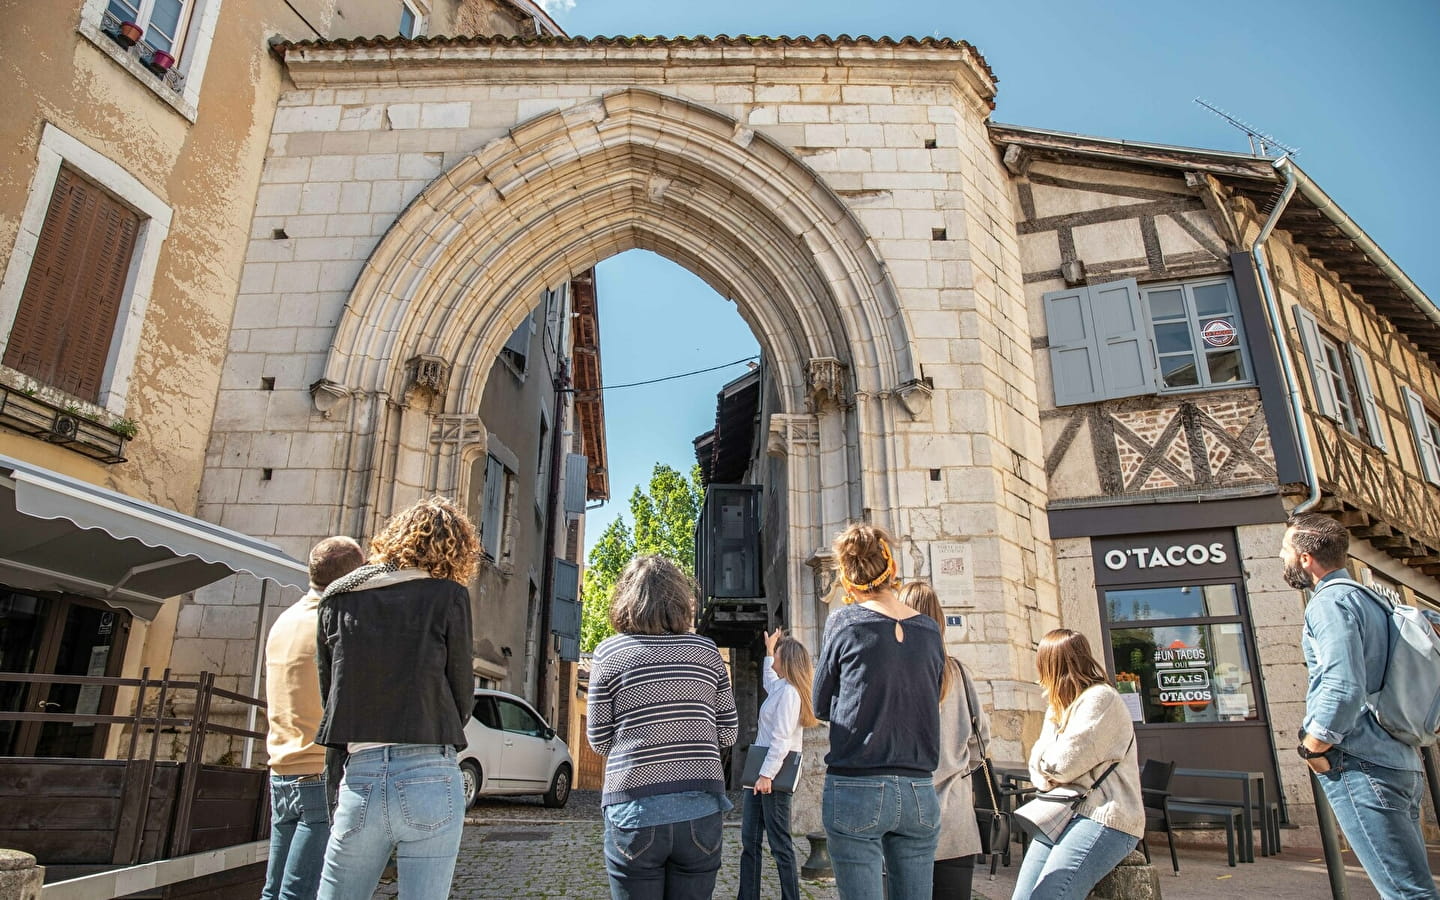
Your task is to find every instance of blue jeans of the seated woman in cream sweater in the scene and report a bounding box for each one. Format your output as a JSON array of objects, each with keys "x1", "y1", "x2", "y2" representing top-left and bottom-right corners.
[{"x1": 1009, "y1": 815, "x2": 1140, "y2": 900}]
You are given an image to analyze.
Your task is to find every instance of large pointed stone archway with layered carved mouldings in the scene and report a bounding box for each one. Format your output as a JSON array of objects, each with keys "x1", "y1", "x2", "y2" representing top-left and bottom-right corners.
[{"x1": 324, "y1": 88, "x2": 929, "y2": 642}]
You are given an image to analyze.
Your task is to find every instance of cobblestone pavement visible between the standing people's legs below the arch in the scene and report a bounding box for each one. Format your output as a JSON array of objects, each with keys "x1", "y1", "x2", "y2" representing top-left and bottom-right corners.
[{"x1": 374, "y1": 791, "x2": 838, "y2": 900}]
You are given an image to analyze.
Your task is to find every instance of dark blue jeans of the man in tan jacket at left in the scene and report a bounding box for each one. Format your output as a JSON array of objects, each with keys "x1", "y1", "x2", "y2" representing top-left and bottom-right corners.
[{"x1": 261, "y1": 775, "x2": 330, "y2": 900}]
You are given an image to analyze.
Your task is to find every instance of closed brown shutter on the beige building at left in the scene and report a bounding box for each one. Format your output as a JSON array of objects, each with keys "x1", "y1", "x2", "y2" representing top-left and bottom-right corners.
[{"x1": 4, "y1": 166, "x2": 140, "y2": 400}]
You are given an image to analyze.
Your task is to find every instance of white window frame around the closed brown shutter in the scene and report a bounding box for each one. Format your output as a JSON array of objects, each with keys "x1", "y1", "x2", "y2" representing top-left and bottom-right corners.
[{"x1": 0, "y1": 122, "x2": 171, "y2": 416}]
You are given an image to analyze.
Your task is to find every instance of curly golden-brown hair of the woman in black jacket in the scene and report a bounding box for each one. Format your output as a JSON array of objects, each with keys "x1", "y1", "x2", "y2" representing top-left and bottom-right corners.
[{"x1": 370, "y1": 497, "x2": 480, "y2": 585}]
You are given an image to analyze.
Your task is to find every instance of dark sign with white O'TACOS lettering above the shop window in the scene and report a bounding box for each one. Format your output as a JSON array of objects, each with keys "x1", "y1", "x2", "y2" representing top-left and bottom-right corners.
[{"x1": 1090, "y1": 528, "x2": 1240, "y2": 585}]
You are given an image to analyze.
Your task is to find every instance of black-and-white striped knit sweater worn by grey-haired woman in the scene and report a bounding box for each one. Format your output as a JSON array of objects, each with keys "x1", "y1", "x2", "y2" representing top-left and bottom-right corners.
[{"x1": 586, "y1": 635, "x2": 739, "y2": 806}]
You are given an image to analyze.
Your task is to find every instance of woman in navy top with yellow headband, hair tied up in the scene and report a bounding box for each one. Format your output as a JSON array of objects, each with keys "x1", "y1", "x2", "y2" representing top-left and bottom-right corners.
[{"x1": 814, "y1": 523, "x2": 945, "y2": 900}]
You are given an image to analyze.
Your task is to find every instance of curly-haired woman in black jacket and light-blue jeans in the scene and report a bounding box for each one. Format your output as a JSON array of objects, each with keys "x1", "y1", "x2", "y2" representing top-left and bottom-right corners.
[{"x1": 315, "y1": 497, "x2": 480, "y2": 900}]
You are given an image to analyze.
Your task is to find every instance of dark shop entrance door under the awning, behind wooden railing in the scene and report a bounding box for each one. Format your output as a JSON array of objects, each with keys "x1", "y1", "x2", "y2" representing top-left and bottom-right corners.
[{"x1": 0, "y1": 586, "x2": 130, "y2": 759}]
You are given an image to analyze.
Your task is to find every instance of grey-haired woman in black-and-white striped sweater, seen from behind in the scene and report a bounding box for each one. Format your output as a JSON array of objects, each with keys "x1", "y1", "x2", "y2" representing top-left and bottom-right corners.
[{"x1": 586, "y1": 556, "x2": 739, "y2": 900}]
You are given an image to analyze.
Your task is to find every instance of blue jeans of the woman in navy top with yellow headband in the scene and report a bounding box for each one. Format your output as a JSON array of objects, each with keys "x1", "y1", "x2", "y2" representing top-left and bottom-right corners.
[{"x1": 821, "y1": 775, "x2": 940, "y2": 900}]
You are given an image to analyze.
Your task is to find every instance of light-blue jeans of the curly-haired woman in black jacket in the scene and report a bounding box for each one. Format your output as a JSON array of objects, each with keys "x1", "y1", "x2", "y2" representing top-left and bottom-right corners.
[{"x1": 318, "y1": 744, "x2": 465, "y2": 900}]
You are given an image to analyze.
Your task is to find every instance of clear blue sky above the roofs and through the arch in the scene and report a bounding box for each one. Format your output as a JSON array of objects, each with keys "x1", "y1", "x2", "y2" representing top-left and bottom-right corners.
[{"x1": 561, "y1": 0, "x2": 1440, "y2": 555}]
